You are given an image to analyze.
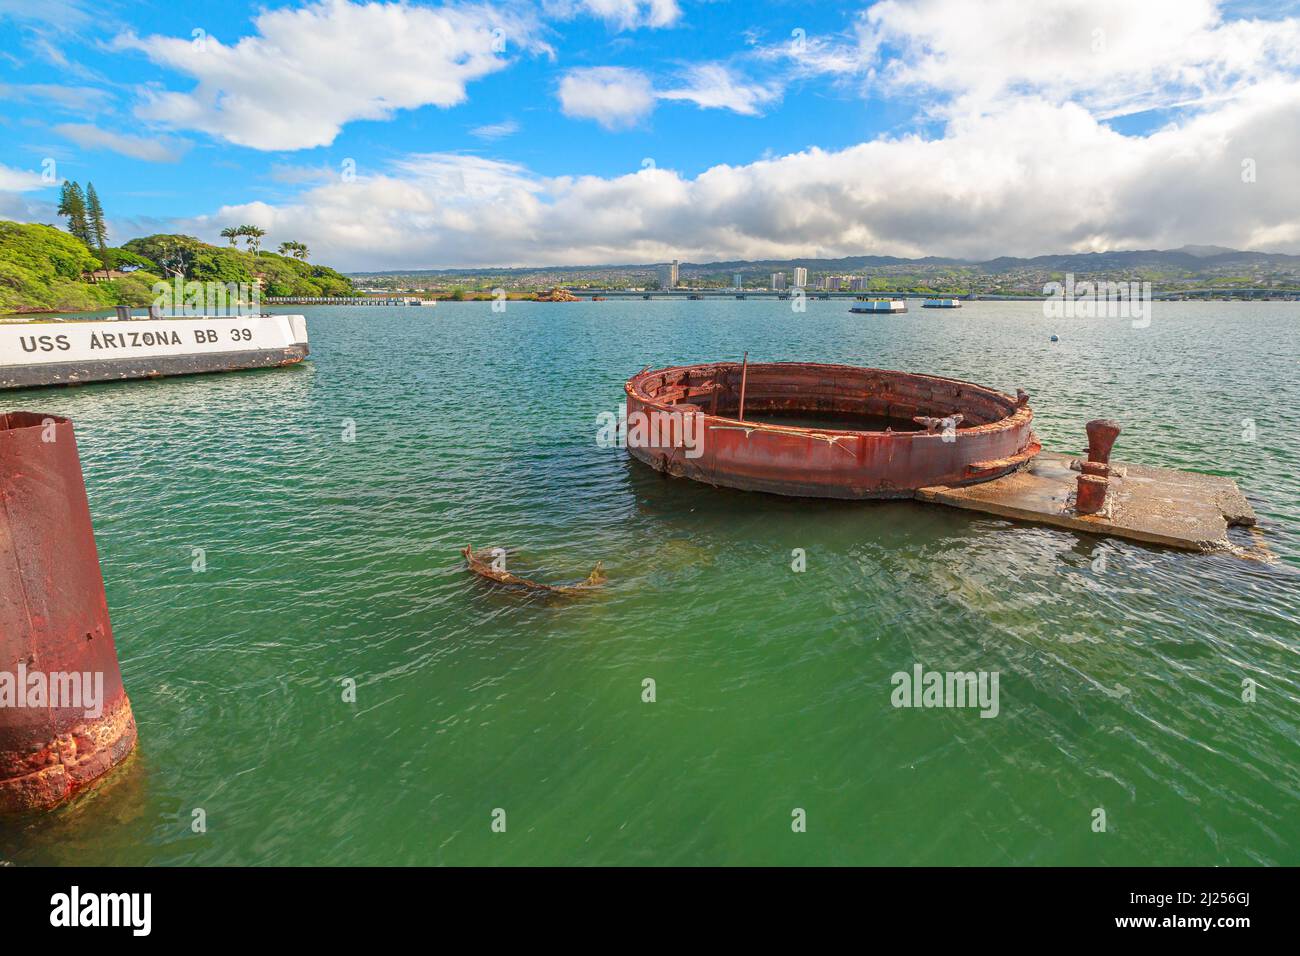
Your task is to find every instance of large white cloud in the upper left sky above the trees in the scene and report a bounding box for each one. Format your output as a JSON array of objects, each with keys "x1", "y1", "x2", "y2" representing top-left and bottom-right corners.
[{"x1": 114, "y1": 0, "x2": 545, "y2": 150}]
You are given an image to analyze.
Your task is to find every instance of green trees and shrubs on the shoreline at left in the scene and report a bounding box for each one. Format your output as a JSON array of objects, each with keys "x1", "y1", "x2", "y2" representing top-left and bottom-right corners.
[{"x1": 0, "y1": 182, "x2": 358, "y2": 315}]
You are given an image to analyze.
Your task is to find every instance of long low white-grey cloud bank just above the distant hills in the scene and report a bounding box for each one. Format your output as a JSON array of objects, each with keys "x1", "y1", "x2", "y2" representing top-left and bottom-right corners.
[{"x1": 167, "y1": 82, "x2": 1300, "y2": 269}]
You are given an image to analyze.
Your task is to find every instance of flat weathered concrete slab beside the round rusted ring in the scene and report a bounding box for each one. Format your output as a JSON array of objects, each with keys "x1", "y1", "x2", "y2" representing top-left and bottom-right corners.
[{"x1": 917, "y1": 451, "x2": 1268, "y2": 559}]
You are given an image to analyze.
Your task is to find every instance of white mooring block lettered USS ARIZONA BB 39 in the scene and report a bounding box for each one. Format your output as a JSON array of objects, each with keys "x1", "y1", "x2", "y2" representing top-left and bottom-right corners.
[{"x1": 0, "y1": 315, "x2": 308, "y2": 389}]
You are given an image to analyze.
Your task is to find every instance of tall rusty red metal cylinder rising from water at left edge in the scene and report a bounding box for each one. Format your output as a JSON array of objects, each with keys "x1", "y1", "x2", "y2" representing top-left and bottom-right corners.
[{"x1": 0, "y1": 411, "x2": 135, "y2": 812}]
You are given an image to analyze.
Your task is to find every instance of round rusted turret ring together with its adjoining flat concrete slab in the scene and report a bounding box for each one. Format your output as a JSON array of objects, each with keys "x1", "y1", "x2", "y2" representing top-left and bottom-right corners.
[{"x1": 624, "y1": 356, "x2": 1268, "y2": 557}]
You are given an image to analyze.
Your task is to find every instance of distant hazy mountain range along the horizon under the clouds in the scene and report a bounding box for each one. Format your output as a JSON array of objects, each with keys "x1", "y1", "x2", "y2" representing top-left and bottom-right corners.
[{"x1": 347, "y1": 246, "x2": 1300, "y2": 278}]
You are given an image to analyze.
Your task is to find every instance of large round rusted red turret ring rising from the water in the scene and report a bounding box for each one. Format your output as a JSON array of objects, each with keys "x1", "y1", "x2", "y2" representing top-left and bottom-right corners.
[{"x1": 625, "y1": 363, "x2": 1041, "y2": 498}]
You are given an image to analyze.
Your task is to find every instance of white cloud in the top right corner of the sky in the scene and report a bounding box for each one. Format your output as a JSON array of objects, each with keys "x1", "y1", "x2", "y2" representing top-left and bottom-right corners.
[{"x1": 858, "y1": 0, "x2": 1300, "y2": 116}]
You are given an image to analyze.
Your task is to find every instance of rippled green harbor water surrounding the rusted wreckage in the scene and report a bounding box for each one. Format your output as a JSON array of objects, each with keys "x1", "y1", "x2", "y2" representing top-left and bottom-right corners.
[{"x1": 0, "y1": 300, "x2": 1300, "y2": 865}]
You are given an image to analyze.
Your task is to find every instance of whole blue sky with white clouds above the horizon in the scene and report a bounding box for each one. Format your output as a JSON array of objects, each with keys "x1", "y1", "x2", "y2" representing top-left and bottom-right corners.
[{"x1": 0, "y1": 0, "x2": 1300, "y2": 268}]
